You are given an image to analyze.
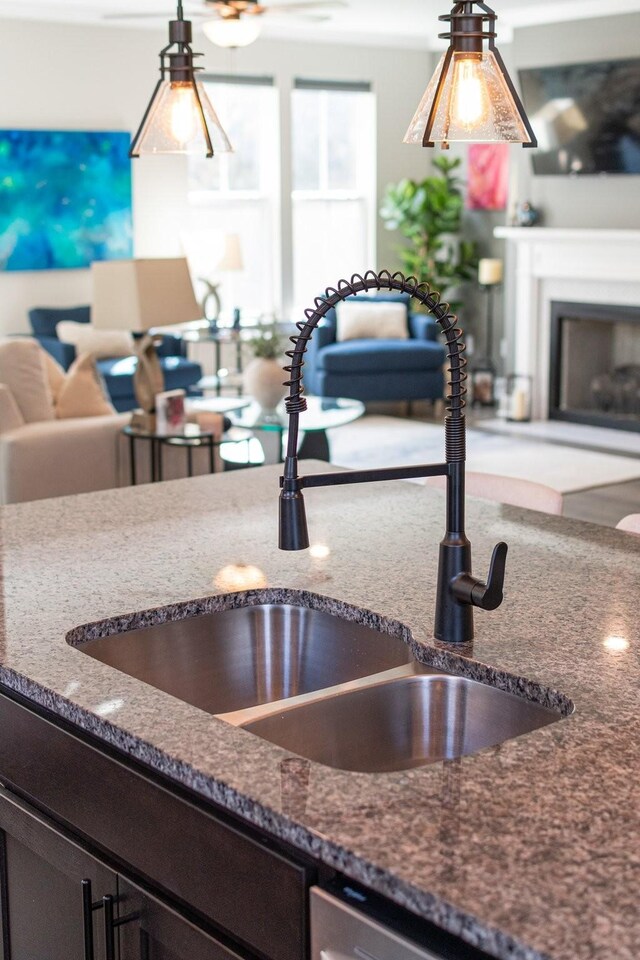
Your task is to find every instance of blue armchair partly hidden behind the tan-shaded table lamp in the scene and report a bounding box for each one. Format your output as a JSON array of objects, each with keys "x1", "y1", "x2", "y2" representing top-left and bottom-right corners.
[{"x1": 29, "y1": 306, "x2": 202, "y2": 413}]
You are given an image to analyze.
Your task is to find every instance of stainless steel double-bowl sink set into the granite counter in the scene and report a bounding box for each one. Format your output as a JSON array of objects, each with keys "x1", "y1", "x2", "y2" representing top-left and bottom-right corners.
[{"x1": 77, "y1": 603, "x2": 561, "y2": 773}]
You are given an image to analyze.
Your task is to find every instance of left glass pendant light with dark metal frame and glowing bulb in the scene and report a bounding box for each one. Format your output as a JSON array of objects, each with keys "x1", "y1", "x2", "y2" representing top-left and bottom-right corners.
[{"x1": 129, "y1": 0, "x2": 233, "y2": 157}]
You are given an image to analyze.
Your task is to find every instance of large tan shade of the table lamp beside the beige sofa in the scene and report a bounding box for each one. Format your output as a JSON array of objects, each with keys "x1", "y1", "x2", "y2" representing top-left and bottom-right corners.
[{"x1": 91, "y1": 257, "x2": 202, "y2": 333}]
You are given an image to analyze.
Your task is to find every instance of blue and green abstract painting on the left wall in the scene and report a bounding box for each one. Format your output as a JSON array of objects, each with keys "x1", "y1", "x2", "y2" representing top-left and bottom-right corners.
[{"x1": 0, "y1": 130, "x2": 133, "y2": 270}]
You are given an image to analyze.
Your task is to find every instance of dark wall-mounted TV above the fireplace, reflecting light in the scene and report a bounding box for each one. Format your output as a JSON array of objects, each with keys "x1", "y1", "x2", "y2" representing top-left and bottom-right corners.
[{"x1": 520, "y1": 59, "x2": 640, "y2": 175}]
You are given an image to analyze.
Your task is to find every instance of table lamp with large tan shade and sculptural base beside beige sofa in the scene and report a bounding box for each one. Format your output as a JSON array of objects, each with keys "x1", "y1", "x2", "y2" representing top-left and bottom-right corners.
[{"x1": 91, "y1": 257, "x2": 201, "y2": 428}]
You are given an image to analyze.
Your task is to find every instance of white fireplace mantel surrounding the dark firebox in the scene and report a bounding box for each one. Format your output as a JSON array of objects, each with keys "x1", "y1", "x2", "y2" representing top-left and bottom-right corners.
[{"x1": 495, "y1": 227, "x2": 640, "y2": 420}]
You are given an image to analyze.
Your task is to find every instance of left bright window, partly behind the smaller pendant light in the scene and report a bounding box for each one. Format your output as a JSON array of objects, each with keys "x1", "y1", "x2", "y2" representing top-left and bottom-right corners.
[{"x1": 183, "y1": 76, "x2": 281, "y2": 321}]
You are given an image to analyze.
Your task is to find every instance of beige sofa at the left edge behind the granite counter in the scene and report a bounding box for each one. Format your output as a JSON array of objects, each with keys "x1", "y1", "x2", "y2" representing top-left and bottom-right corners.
[{"x1": 0, "y1": 338, "x2": 224, "y2": 504}]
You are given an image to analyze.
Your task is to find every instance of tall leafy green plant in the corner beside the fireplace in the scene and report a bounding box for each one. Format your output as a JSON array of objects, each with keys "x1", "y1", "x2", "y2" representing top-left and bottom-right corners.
[{"x1": 380, "y1": 156, "x2": 478, "y2": 309}]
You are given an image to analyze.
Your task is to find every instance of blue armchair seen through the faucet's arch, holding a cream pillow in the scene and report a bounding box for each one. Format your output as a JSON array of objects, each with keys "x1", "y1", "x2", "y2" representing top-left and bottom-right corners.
[{"x1": 304, "y1": 293, "x2": 446, "y2": 401}]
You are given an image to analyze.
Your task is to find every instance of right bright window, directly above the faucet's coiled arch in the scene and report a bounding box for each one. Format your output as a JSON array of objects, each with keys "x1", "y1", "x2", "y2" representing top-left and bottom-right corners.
[{"x1": 291, "y1": 80, "x2": 376, "y2": 312}]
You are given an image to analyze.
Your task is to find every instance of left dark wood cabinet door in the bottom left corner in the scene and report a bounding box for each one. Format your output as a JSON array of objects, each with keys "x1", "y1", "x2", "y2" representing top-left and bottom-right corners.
[{"x1": 0, "y1": 787, "x2": 117, "y2": 960}]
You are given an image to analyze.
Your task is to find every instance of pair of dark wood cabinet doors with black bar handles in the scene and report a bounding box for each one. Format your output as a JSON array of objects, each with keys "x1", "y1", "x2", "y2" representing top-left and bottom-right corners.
[{"x1": 0, "y1": 788, "x2": 247, "y2": 960}]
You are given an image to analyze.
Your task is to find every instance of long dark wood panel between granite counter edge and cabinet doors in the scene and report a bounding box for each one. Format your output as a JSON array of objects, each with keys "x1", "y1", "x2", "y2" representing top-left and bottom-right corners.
[{"x1": 0, "y1": 691, "x2": 317, "y2": 960}]
